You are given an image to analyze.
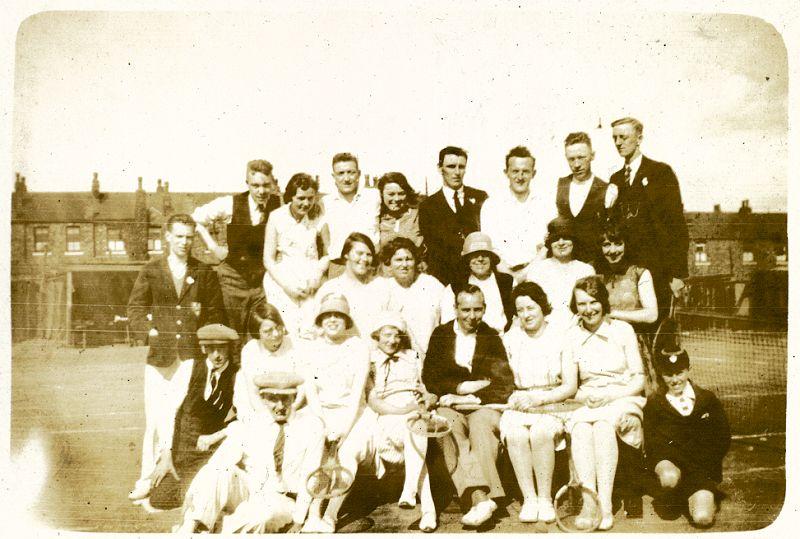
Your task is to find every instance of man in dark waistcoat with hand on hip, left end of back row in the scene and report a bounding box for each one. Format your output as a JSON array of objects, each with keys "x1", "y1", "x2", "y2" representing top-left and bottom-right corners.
[{"x1": 192, "y1": 160, "x2": 281, "y2": 333}]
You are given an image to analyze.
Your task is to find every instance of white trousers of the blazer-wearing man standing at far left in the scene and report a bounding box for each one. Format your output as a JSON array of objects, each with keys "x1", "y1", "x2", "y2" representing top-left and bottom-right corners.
[{"x1": 136, "y1": 359, "x2": 194, "y2": 487}]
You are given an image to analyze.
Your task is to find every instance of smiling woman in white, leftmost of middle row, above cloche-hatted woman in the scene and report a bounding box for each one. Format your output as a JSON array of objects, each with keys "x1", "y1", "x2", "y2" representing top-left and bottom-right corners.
[{"x1": 307, "y1": 232, "x2": 380, "y2": 335}]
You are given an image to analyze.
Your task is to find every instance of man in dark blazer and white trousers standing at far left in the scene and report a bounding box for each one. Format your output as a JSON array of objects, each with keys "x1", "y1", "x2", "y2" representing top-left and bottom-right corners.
[{"x1": 128, "y1": 214, "x2": 225, "y2": 502}]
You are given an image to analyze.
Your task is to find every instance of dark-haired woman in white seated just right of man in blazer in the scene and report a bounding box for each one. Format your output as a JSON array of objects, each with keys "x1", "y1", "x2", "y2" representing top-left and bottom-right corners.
[{"x1": 500, "y1": 282, "x2": 578, "y2": 522}]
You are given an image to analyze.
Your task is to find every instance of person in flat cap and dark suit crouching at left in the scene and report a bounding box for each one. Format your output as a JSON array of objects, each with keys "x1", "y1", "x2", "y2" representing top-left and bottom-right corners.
[{"x1": 150, "y1": 324, "x2": 239, "y2": 509}]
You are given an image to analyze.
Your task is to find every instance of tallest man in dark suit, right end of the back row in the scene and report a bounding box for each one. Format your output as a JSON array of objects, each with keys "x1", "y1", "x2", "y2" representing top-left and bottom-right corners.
[{"x1": 611, "y1": 118, "x2": 689, "y2": 320}]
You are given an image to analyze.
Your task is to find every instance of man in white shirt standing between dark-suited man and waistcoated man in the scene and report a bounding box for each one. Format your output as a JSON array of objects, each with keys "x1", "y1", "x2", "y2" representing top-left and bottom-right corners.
[{"x1": 481, "y1": 146, "x2": 556, "y2": 282}]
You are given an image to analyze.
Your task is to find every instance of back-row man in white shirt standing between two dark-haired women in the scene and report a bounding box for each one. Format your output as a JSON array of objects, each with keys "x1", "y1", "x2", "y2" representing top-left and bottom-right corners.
[{"x1": 322, "y1": 153, "x2": 381, "y2": 277}]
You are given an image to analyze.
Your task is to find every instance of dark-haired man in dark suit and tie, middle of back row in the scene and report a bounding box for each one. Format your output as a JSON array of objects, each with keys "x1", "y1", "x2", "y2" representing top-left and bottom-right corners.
[{"x1": 419, "y1": 146, "x2": 488, "y2": 286}]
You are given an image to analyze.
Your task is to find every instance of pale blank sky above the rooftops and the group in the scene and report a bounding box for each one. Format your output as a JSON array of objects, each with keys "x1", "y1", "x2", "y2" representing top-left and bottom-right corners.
[{"x1": 11, "y1": 3, "x2": 789, "y2": 211}]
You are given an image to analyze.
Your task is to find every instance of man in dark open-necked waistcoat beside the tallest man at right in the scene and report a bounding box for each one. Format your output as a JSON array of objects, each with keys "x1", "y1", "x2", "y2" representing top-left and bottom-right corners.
[{"x1": 556, "y1": 132, "x2": 618, "y2": 264}]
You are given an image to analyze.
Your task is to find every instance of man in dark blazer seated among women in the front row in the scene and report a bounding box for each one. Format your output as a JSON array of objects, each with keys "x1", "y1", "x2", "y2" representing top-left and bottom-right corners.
[{"x1": 422, "y1": 285, "x2": 514, "y2": 527}]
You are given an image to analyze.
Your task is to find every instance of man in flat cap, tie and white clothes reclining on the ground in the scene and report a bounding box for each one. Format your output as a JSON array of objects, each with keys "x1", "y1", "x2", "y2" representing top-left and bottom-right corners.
[{"x1": 177, "y1": 372, "x2": 325, "y2": 533}]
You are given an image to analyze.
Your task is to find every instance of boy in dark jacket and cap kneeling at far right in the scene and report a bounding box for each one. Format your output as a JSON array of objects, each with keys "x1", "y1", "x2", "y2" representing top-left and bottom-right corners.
[{"x1": 644, "y1": 350, "x2": 731, "y2": 527}]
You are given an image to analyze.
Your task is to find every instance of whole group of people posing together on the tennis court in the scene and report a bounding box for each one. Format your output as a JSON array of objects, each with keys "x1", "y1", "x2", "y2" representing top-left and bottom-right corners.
[{"x1": 129, "y1": 118, "x2": 730, "y2": 533}]
